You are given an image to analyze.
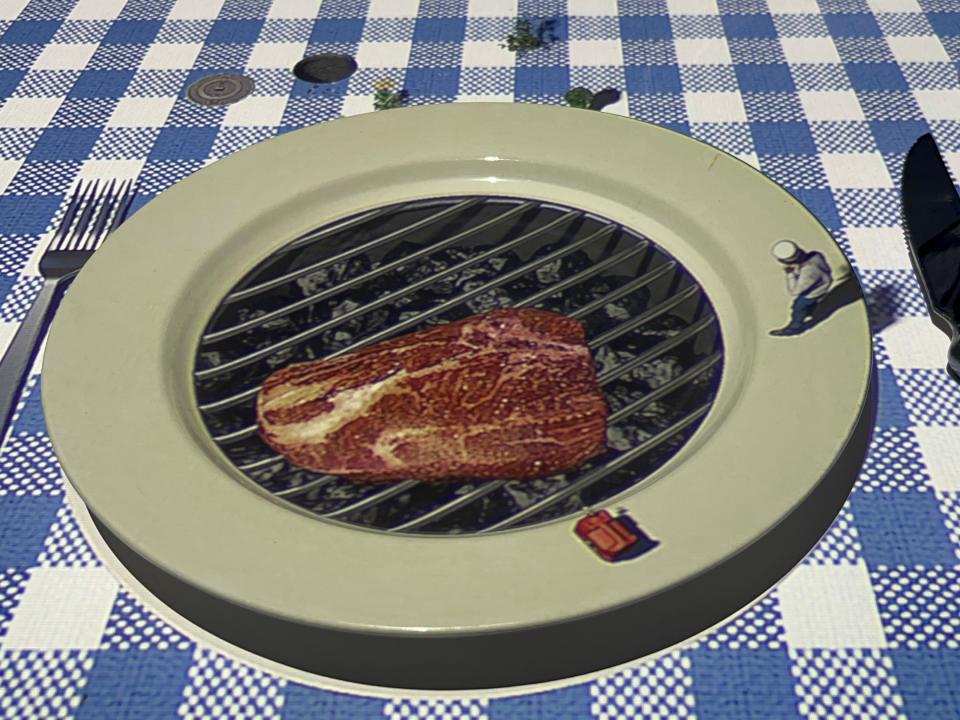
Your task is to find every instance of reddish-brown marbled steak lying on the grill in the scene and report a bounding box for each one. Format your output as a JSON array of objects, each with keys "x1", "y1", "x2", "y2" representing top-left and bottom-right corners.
[{"x1": 257, "y1": 309, "x2": 607, "y2": 481}]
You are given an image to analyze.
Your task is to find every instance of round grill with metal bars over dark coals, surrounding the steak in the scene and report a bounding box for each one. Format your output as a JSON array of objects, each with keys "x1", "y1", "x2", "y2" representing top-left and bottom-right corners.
[{"x1": 194, "y1": 197, "x2": 722, "y2": 535}]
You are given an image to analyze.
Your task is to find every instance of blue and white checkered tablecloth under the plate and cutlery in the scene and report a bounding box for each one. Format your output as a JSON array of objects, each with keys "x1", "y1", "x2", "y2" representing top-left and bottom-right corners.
[{"x1": 0, "y1": 0, "x2": 960, "y2": 720}]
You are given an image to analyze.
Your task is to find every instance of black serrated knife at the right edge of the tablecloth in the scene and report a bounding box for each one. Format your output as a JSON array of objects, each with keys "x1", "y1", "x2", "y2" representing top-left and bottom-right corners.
[{"x1": 902, "y1": 133, "x2": 960, "y2": 382}]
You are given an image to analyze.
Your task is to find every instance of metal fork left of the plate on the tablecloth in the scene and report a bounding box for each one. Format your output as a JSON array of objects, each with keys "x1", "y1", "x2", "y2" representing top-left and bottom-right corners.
[{"x1": 0, "y1": 180, "x2": 136, "y2": 441}]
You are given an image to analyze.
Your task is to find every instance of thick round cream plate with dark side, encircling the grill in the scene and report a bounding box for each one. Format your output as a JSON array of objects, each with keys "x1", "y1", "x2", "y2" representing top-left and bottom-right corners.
[{"x1": 43, "y1": 103, "x2": 876, "y2": 689}]
